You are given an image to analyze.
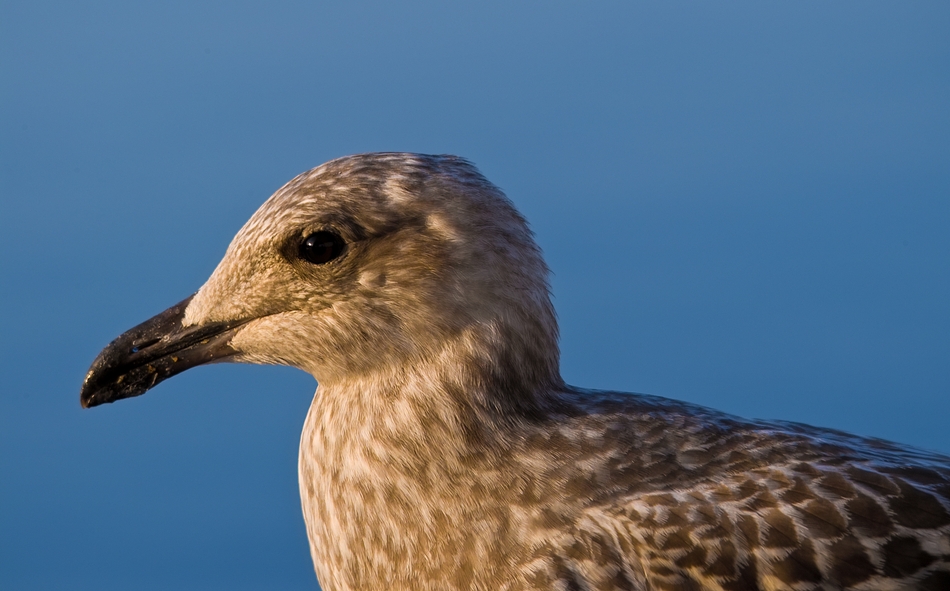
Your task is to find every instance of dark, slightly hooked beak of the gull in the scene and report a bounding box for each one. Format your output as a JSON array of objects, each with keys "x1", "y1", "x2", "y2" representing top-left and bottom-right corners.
[{"x1": 79, "y1": 295, "x2": 247, "y2": 408}]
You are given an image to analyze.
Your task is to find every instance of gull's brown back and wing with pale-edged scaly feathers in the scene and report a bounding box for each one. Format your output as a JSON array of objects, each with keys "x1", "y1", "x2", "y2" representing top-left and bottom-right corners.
[{"x1": 520, "y1": 393, "x2": 950, "y2": 591}]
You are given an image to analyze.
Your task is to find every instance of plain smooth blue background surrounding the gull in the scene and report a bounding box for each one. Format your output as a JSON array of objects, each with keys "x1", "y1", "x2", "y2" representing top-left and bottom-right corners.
[{"x1": 0, "y1": 0, "x2": 950, "y2": 590}]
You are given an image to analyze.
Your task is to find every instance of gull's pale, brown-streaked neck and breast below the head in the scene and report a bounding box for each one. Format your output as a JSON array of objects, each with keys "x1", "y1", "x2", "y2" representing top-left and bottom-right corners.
[{"x1": 299, "y1": 328, "x2": 559, "y2": 589}]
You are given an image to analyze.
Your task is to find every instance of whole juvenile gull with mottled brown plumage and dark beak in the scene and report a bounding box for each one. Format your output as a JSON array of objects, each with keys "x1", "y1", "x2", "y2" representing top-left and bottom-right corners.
[{"x1": 81, "y1": 154, "x2": 950, "y2": 591}]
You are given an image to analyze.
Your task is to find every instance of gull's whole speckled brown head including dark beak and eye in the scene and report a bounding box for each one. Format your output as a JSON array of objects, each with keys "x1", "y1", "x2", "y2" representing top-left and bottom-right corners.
[{"x1": 81, "y1": 153, "x2": 560, "y2": 406}]
